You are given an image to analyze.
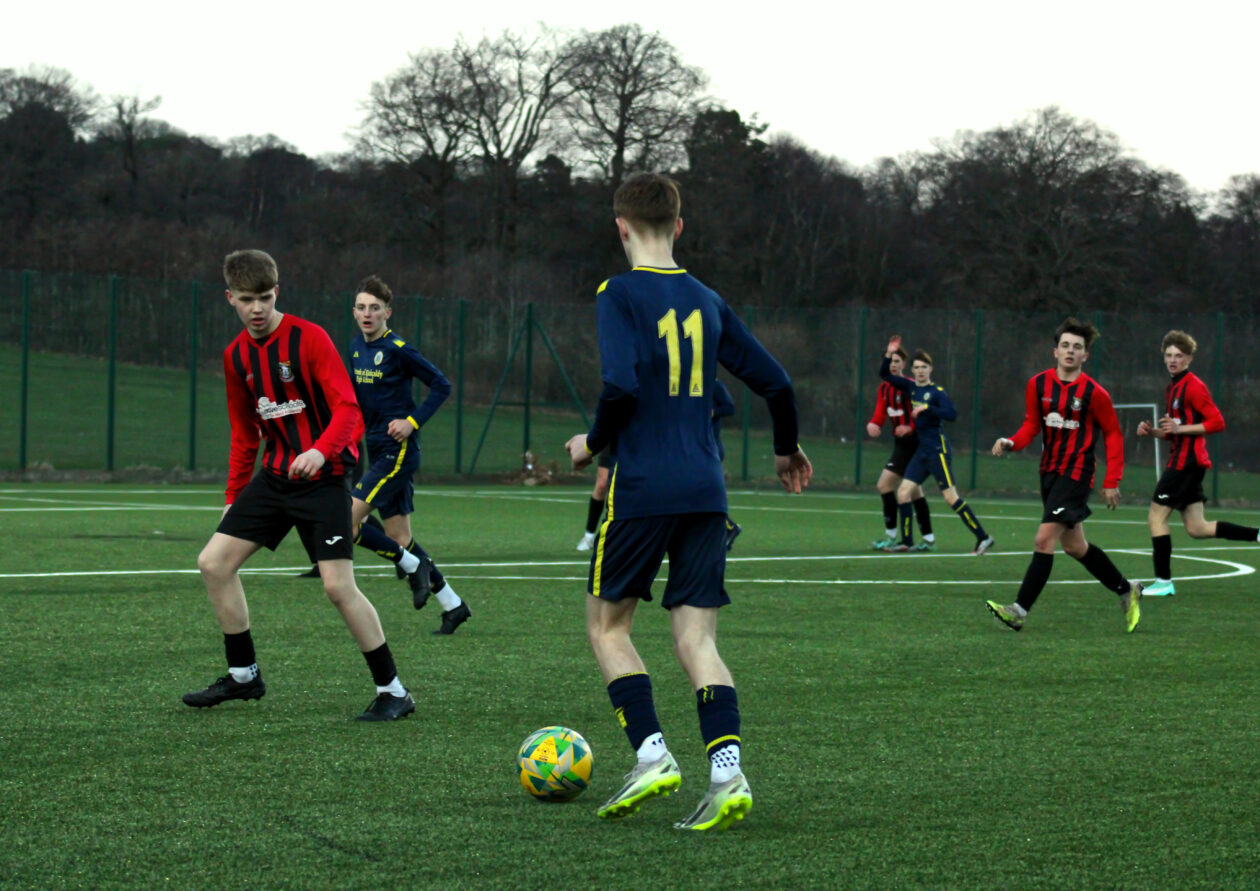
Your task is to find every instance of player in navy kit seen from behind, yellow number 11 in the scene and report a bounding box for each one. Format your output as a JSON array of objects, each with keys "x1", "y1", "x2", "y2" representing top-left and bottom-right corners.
[{"x1": 566, "y1": 174, "x2": 813, "y2": 829}]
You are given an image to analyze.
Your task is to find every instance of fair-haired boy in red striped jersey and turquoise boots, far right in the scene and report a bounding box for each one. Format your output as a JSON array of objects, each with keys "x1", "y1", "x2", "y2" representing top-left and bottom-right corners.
[{"x1": 1138, "y1": 331, "x2": 1260, "y2": 596}]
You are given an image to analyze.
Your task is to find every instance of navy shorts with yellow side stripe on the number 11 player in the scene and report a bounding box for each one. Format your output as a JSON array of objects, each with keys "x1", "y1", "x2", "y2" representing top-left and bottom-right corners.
[{"x1": 586, "y1": 513, "x2": 731, "y2": 610}]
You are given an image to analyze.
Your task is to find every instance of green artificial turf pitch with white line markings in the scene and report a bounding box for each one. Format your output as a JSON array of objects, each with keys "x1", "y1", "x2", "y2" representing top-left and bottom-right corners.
[{"x1": 0, "y1": 484, "x2": 1260, "y2": 888}]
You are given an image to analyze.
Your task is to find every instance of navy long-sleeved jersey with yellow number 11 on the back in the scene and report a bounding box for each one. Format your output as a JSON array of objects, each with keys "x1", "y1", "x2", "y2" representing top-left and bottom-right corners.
[{"x1": 596, "y1": 266, "x2": 791, "y2": 519}]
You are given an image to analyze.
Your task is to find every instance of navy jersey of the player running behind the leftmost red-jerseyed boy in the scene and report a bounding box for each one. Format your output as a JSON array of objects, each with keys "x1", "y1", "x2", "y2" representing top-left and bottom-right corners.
[{"x1": 350, "y1": 329, "x2": 451, "y2": 442}]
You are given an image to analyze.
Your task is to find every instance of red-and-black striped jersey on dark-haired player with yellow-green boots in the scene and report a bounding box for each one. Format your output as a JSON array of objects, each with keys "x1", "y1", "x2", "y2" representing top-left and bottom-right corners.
[{"x1": 1011, "y1": 368, "x2": 1124, "y2": 489}]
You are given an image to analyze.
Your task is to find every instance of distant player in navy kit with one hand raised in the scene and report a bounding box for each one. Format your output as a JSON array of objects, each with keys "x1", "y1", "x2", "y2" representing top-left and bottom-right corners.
[{"x1": 879, "y1": 334, "x2": 993, "y2": 557}]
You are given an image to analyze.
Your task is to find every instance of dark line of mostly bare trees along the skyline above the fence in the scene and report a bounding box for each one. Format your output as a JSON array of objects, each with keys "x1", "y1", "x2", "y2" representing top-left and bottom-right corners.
[{"x1": 0, "y1": 25, "x2": 1260, "y2": 311}]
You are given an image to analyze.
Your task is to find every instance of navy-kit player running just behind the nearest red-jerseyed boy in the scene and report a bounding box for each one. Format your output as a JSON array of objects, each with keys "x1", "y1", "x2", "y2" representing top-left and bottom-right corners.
[{"x1": 350, "y1": 276, "x2": 473, "y2": 634}]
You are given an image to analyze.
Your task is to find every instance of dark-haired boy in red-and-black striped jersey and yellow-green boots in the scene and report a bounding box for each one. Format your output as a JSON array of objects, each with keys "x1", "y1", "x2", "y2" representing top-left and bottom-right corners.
[{"x1": 985, "y1": 319, "x2": 1142, "y2": 631}]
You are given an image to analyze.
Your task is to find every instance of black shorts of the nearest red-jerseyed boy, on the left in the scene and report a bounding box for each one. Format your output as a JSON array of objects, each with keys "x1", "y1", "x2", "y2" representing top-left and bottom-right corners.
[{"x1": 218, "y1": 471, "x2": 354, "y2": 560}]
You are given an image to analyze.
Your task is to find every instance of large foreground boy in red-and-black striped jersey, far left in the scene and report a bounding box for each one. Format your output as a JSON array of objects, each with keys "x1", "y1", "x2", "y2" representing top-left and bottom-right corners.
[{"x1": 184, "y1": 251, "x2": 416, "y2": 721}]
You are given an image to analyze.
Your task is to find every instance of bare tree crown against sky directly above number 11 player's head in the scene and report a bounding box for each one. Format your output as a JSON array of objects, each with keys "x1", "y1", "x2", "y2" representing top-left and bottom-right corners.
[{"x1": 564, "y1": 24, "x2": 706, "y2": 185}]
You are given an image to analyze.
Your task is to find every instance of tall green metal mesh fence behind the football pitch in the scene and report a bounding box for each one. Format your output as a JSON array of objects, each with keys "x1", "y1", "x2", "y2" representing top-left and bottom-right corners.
[{"x1": 0, "y1": 264, "x2": 1260, "y2": 502}]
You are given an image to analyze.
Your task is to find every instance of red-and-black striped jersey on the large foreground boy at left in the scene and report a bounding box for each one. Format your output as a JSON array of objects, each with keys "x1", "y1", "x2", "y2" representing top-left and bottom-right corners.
[{"x1": 223, "y1": 314, "x2": 363, "y2": 504}]
